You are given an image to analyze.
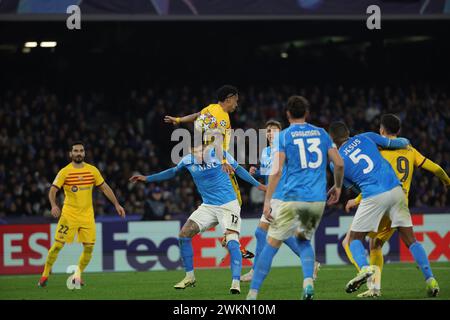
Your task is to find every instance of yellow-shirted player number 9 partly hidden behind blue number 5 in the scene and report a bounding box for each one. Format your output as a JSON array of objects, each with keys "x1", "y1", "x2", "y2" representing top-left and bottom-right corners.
[{"x1": 342, "y1": 114, "x2": 450, "y2": 297}]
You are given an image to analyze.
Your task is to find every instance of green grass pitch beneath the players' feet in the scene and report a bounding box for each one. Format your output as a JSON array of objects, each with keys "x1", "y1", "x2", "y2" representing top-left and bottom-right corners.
[{"x1": 0, "y1": 262, "x2": 450, "y2": 300}]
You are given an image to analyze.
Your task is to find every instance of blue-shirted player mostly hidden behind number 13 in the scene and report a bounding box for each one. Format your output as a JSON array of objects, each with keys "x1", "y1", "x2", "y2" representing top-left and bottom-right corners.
[{"x1": 241, "y1": 120, "x2": 320, "y2": 282}]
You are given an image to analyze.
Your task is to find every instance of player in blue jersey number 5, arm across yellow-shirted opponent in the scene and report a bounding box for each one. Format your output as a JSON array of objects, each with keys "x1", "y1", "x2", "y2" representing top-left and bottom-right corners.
[{"x1": 330, "y1": 122, "x2": 439, "y2": 294}]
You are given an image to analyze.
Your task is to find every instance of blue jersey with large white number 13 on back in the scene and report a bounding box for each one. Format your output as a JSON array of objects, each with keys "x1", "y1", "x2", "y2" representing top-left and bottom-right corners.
[{"x1": 274, "y1": 123, "x2": 333, "y2": 202}]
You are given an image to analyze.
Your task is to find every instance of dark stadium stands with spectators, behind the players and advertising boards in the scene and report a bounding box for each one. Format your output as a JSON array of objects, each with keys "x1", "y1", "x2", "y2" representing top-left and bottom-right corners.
[{"x1": 0, "y1": 0, "x2": 450, "y2": 223}]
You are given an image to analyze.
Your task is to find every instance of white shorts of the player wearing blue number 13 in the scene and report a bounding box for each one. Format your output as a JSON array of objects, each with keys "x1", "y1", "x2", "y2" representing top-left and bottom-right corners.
[{"x1": 268, "y1": 201, "x2": 325, "y2": 241}]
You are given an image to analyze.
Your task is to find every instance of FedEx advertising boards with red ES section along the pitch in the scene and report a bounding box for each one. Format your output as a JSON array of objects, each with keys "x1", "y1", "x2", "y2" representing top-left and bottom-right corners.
[{"x1": 0, "y1": 214, "x2": 450, "y2": 274}]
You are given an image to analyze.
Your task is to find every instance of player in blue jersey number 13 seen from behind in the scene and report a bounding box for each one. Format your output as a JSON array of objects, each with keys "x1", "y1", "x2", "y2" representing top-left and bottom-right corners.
[{"x1": 247, "y1": 96, "x2": 344, "y2": 300}]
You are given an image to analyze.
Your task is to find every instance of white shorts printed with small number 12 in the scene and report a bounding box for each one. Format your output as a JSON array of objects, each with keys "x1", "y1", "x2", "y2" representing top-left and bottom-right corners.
[{"x1": 189, "y1": 200, "x2": 241, "y2": 233}]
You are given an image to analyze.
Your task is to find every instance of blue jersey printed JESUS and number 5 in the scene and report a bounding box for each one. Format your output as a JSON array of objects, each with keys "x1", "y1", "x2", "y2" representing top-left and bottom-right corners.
[{"x1": 339, "y1": 132, "x2": 406, "y2": 199}]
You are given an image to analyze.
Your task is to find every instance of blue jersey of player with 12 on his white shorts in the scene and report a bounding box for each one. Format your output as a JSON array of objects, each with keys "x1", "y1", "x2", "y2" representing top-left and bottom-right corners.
[{"x1": 176, "y1": 149, "x2": 238, "y2": 206}]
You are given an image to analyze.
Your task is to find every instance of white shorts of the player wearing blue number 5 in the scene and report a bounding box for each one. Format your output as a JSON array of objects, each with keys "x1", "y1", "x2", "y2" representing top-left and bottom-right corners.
[{"x1": 351, "y1": 186, "x2": 413, "y2": 232}]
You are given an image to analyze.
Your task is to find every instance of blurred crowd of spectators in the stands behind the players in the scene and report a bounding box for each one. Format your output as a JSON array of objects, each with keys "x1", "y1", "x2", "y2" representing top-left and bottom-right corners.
[{"x1": 0, "y1": 85, "x2": 450, "y2": 220}]
